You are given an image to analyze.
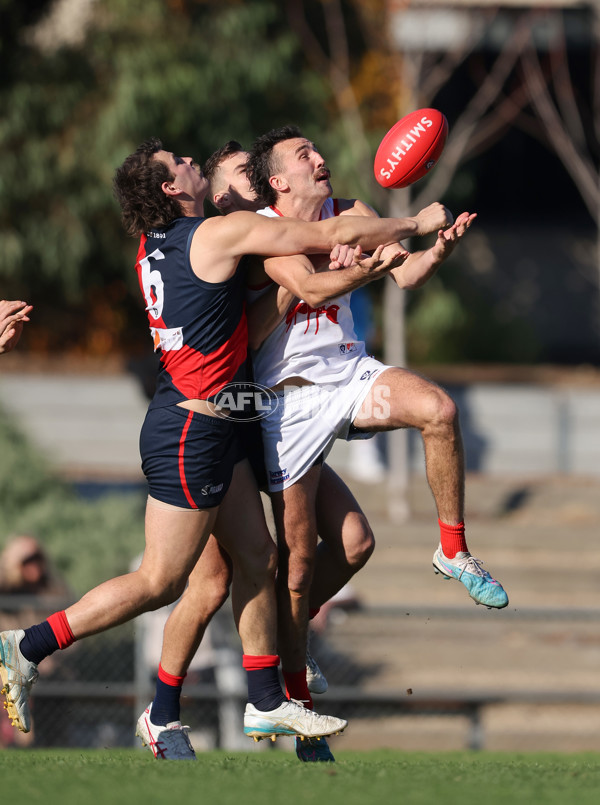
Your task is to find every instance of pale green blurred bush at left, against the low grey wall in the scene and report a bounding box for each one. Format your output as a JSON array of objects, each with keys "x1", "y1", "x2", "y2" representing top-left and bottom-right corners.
[{"x1": 0, "y1": 410, "x2": 145, "y2": 594}]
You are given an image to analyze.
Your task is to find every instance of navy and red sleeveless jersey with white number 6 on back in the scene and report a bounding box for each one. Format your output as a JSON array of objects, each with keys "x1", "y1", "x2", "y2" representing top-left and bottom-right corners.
[{"x1": 136, "y1": 218, "x2": 248, "y2": 408}]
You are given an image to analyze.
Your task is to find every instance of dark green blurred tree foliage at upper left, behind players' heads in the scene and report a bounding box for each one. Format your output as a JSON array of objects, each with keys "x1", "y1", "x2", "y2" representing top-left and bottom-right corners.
[{"x1": 0, "y1": 0, "x2": 326, "y2": 354}]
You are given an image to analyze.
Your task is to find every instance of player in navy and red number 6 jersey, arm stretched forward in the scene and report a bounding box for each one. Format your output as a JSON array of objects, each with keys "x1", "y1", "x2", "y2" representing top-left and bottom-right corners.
[{"x1": 0, "y1": 139, "x2": 434, "y2": 757}]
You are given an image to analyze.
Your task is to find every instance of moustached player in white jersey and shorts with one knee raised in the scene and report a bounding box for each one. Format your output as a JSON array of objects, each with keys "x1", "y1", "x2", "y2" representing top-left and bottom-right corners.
[{"x1": 240, "y1": 126, "x2": 508, "y2": 716}]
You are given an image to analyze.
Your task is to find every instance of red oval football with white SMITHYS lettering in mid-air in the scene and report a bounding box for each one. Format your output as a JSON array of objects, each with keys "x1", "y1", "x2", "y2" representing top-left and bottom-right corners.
[{"x1": 374, "y1": 109, "x2": 448, "y2": 187}]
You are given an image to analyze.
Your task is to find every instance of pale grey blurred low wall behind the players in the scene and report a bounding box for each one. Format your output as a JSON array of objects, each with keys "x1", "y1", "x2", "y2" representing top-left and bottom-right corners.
[{"x1": 0, "y1": 372, "x2": 600, "y2": 479}]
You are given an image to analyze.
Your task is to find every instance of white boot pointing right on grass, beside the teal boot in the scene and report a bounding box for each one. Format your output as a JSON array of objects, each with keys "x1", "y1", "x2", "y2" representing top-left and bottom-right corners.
[{"x1": 244, "y1": 699, "x2": 348, "y2": 741}]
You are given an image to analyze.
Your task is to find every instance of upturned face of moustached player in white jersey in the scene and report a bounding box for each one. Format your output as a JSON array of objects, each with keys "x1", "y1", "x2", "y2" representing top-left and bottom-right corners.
[{"x1": 273, "y1": 137, "x2": 333, "y2": 201}]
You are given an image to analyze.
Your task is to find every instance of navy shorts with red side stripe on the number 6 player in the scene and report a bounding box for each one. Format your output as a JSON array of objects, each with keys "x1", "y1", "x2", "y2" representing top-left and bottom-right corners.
[{"x1": 140, "y1": 405, "x2": 239, "y2": 509}]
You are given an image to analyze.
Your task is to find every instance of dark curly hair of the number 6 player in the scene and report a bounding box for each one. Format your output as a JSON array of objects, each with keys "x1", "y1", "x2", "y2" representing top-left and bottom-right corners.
[{"x1": 113, "y1": 137, "x2": 184, "y2": 237}]
